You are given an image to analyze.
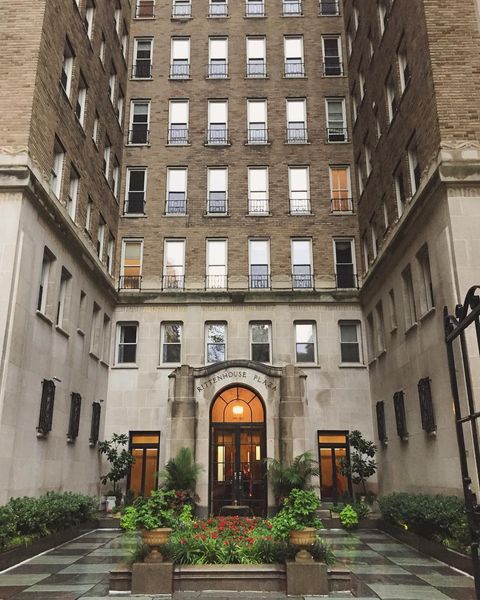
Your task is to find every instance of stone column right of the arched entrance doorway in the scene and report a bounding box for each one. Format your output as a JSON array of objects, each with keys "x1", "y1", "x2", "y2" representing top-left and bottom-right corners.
[{"x1": 279, "y1": 365, "x2": 307, "y2": 462}]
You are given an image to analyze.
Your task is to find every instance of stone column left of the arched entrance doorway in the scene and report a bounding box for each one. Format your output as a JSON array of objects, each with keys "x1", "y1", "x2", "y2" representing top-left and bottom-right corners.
[{"x1": 170, "y1": 365, "x2": 197, "y2": 456}]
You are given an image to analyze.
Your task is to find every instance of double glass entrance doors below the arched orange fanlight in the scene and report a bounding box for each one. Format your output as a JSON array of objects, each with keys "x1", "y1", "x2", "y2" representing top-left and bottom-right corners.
[{"x1": 210, "y1": 425, "x2": 267, "y2": 516}]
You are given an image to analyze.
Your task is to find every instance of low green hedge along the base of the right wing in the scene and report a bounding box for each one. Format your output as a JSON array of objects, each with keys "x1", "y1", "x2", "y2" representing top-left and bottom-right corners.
[{"x1": 378, "y1": 493, "x2": 469, "y2": 551}]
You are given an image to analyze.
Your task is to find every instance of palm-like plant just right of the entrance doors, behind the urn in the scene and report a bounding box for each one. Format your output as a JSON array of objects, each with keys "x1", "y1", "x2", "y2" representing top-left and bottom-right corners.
[{"x1": 267, "y1": 452, "x2": 319, "y2": 506}]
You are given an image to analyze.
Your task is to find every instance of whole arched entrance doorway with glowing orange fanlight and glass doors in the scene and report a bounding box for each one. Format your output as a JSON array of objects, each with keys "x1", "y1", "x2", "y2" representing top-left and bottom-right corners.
[{"x1": 209, "y1": 385, "x2": 267, "y2": 516}]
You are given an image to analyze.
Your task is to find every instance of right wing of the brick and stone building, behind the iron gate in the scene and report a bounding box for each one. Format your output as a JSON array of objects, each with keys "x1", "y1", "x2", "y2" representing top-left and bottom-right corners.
[{"x1": 345, "y1": 0, "x2": 480, "y2": 493}]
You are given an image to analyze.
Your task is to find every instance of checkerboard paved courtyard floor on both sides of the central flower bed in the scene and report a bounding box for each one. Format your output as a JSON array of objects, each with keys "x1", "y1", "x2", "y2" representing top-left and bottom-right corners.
[{"x1": 0, "y1": 530, "x2": 475, "y2": 600}]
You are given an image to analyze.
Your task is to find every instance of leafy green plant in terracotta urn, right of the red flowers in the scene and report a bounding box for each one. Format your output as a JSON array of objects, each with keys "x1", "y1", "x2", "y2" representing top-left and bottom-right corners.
[{"x1": 272, "y1": 489, "x2": 322, "y2": 562}]
